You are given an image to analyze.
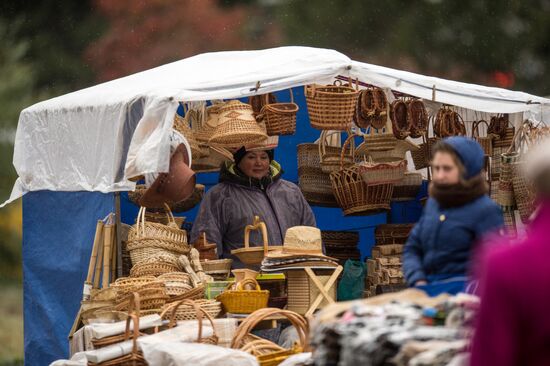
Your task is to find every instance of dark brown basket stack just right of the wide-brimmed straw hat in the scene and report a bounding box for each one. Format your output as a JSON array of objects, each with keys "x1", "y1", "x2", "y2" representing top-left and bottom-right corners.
[{"x1": 321, "y1": 230, "x2": 361, "y2": 263}]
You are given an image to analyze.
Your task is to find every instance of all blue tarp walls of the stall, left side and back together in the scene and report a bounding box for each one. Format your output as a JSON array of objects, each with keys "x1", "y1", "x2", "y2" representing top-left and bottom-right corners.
[{"x1": 23, "y1": 88, "x2": 426, "y2": 365}]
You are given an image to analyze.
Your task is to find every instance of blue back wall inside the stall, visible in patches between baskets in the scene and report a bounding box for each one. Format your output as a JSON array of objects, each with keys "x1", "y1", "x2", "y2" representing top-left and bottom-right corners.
[{"x1": 121, "y1": 88, "x2": 426, "y2": 259}]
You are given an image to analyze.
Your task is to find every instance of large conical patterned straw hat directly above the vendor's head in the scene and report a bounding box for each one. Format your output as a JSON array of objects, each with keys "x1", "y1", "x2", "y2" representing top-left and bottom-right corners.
[{"x1": 209, "y1": 100, "x2": 267, "y2": 147}]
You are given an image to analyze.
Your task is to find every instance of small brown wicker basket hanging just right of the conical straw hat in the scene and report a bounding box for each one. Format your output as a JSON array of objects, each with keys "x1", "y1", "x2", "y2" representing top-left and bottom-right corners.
[{"x1": 256, "y1": 88, "x2": 298, "y2": 136}]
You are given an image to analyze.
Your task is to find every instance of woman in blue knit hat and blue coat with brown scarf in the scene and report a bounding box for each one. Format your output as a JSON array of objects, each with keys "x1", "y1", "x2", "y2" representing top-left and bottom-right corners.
[{"x1": 403, "y1": 136, "x2": 504, "y2": 296}]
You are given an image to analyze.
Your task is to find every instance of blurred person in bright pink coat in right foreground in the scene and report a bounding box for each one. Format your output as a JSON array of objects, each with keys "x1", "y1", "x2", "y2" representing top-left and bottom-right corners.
[{"x1": 470, "y1": 139, "x2": 550, "y2": 366}]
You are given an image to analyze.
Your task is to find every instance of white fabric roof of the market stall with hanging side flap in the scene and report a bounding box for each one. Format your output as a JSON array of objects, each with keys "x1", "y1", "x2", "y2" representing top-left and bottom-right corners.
[{"x1": 0, "y1": 47, "x2": 550, "y2": 207}]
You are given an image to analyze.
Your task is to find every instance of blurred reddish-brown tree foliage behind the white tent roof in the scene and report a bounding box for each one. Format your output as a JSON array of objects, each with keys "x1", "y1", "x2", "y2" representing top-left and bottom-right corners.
[{"x1": 86, "y1": 0, "x2": 279, "y2": 81}]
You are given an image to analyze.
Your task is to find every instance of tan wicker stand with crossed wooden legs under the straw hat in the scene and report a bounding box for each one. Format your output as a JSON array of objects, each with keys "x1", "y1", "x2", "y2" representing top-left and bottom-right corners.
[{"x1": 286, "y1": 270, "x2": 337, "y2": 314}]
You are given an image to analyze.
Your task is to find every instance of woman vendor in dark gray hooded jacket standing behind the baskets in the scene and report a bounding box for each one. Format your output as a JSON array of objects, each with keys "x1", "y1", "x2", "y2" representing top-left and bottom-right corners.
[{"x1": 191, "y1": 147, "x2": 315, "y2": 268}]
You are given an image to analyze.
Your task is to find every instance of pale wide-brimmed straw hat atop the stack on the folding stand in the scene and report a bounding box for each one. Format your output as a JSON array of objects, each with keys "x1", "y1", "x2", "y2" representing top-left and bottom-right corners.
[{"x1": 266, "y1": 226, "x2": 336, "y2": 261}]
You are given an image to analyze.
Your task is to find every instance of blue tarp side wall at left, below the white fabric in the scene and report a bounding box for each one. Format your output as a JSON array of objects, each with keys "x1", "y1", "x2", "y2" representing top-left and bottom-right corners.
[{"x1": 23, "y1": 191, "x2": 114, "y2": 365}]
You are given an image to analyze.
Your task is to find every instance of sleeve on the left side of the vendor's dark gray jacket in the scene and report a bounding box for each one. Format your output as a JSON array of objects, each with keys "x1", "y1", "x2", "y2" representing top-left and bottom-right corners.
[{"x1": 191, "y1": 186, "x2": 227, "y2": 256}]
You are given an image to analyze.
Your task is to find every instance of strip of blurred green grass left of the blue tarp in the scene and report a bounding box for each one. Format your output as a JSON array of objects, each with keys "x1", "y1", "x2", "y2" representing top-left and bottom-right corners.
[{"x1": 0, "y1": 283, "x2": 23, "y2": 366}]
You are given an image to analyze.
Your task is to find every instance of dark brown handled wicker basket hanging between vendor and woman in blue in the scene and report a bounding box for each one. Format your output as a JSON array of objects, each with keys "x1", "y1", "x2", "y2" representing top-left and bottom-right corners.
[{"x1": 330, "y1": 135, "x2": 393, "y2": 215}]
